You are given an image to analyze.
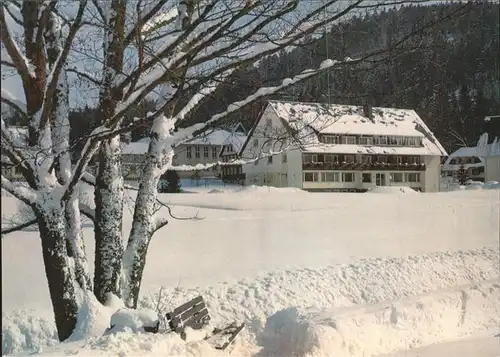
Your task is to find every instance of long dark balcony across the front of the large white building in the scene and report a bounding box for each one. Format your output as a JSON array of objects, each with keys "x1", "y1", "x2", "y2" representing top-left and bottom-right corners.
[{"x1": 302, "y1": 162, "x2": 425, "y2": 171}]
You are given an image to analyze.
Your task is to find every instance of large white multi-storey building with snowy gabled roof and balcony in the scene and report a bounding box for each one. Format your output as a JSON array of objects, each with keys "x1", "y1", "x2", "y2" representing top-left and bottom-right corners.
[{"x1": 240, "y1": 101, "x2": 447, "y2": 192}]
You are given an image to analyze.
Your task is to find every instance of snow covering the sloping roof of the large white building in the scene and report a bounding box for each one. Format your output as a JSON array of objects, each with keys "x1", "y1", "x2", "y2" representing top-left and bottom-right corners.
[{"x1": 269, "y1": 101, "x2": 447, "y2": 155}]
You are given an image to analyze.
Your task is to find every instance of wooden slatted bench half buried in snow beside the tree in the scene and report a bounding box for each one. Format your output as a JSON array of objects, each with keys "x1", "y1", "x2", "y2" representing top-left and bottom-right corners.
[{"x1": 166, "y1": 296, "x2": 245, "y2": 350}]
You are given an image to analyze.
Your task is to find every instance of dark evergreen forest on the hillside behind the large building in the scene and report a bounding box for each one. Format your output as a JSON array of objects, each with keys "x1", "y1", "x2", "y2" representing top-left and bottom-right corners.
[{"x1": 4, "y1": 2, "x2": 500, "y2": 156}]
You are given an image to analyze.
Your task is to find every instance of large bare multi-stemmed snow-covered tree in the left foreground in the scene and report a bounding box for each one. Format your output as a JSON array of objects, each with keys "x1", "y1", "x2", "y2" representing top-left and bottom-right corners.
[{"x1": 0, "y1": 0, "x2": 468, "y2": 340}]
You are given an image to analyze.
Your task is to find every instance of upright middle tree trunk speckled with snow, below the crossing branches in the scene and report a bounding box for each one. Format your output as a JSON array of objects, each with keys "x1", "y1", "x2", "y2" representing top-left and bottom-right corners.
[{"x1": 94, "y1": 136, "x2": 123, "y2": 303}]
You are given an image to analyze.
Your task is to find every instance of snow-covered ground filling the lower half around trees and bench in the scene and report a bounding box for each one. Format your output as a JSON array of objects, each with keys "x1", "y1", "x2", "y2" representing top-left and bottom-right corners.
[{"x1": 2, "y1": 185, "x2": 500, "y2": 357}]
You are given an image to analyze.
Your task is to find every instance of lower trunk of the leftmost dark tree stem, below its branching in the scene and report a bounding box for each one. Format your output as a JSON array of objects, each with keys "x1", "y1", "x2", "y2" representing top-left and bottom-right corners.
[{"x1": 37, "y1": 209, "x2": 78, "y2": 341}]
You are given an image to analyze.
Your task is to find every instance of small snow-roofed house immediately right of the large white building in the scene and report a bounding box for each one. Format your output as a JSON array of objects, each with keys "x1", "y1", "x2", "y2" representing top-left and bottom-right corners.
[{"x1": 442, "y1": 146, "x2": 485, "y2": 181}]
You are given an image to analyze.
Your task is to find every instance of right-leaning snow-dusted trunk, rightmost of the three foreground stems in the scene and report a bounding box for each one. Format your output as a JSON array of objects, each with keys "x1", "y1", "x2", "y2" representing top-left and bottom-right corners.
[{"x1": 122, "y1": 140, "x2": 169, "y2": 308}]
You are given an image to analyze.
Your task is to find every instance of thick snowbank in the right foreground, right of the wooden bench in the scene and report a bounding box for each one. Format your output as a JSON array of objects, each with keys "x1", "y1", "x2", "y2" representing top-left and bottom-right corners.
[{"x1": 259, "y1": 279, "x2": 500, "y2": 357}]
